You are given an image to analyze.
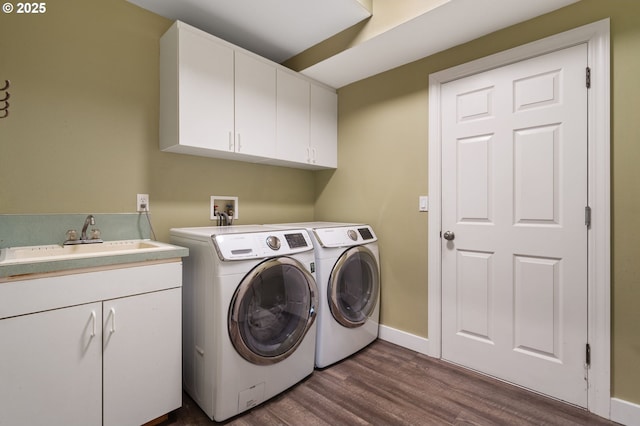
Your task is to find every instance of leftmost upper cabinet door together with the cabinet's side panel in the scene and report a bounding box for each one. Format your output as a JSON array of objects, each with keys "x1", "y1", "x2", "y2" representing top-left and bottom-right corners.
[{"x1": 160, "y1": 22, "x2": 234, "y2": 155}]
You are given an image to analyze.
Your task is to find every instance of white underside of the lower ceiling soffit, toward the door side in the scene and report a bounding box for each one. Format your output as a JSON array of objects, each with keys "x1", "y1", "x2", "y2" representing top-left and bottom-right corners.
[{"x1": 301, "y1": 0, "x2": 579, "y2": 88}]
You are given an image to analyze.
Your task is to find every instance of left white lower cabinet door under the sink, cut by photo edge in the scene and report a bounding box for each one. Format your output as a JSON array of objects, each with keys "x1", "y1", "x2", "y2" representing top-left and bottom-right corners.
[{"x1": 0, "y1": 303, "x2": 102, "y2": 426}]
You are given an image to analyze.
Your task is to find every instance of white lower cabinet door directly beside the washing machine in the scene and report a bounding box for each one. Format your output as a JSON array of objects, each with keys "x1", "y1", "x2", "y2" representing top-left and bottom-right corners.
[{"x1": 103, "y1": 288, "x2": 182, "y2": 426}]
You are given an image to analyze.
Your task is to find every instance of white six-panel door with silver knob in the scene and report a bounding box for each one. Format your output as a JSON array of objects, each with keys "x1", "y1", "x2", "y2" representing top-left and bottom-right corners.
[{"x1": 441, "y1": 44, "x2": 588, "y2": 407}]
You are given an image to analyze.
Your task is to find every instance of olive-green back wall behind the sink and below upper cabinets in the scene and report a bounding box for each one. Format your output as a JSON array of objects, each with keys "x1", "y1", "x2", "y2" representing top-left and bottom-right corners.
[{"x1": 0, "y1": 0, "x2": 314, "y2": 241}]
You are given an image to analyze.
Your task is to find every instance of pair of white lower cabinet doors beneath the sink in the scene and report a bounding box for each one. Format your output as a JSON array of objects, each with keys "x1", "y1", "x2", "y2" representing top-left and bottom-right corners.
[{"x1": 0, "y1": 262, "x2": 182, "y2": 426}]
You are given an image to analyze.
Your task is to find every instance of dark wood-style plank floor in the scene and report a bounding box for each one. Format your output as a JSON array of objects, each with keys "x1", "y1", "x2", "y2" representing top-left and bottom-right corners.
[{"x1": 163, "y1": 340, "x2": 615, "y2": 426}]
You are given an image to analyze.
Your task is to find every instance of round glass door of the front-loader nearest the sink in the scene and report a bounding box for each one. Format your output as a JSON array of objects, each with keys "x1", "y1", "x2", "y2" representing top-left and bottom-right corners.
[{"x1": 228, "y1": 257, "x2": 318, "y2": 365}]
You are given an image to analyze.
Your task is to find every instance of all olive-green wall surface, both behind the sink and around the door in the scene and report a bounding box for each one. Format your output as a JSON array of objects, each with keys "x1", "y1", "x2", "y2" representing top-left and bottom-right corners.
[{"x1": 0, "y1": 0, "x2": 640, "y2": 410}]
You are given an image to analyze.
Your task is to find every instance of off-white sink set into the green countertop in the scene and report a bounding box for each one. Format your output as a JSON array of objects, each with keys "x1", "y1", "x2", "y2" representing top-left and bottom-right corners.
[{"x1": 0, "y1": 240, "x2": 175, "y2": 266}]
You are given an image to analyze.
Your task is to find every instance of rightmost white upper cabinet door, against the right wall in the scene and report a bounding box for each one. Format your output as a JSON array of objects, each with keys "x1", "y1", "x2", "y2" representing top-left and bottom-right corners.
[{"x1": 310, "y1": 84, "x2": 338, "y2": 168}]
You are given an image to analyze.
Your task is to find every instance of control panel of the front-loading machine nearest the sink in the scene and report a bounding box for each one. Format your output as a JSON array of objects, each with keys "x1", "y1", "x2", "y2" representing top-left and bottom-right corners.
[{"x1": 211, "y1": 229, "x2": 313, "y2": 260}]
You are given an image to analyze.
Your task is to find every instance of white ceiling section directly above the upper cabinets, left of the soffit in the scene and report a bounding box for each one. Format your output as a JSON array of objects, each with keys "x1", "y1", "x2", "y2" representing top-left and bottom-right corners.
[{"x1": 128, "y1": 0, "x2": 371, "y2": 63}]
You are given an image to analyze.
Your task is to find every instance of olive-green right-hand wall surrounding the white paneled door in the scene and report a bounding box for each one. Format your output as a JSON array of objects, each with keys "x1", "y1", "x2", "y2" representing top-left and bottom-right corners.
[{"x1": 315, "y1": 0, "x2": 640, "y2": 403}]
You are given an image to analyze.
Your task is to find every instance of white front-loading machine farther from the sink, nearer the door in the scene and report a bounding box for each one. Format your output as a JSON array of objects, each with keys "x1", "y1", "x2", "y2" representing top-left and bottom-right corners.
[{"x1": 268, "y1": 222, "x2": 380, "y2": 368}]
